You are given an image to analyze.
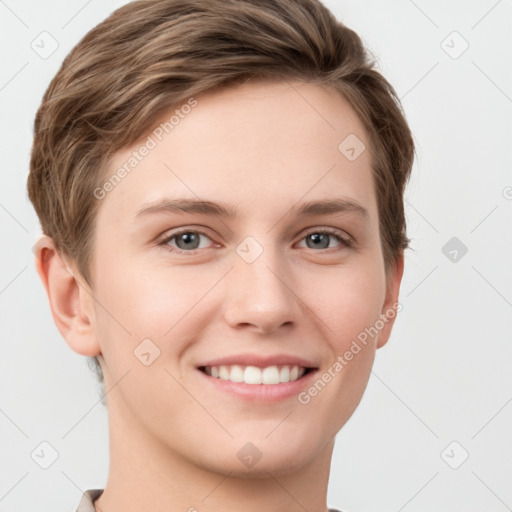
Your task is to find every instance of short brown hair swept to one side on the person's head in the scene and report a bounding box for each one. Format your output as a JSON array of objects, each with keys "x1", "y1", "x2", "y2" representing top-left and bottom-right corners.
[{"x1": 28, "y1": 0, "x2": 414, "y2": 392}]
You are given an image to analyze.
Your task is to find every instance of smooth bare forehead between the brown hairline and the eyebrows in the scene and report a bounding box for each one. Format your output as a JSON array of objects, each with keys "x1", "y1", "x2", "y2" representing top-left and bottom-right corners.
[{"x1": 99, "y1": 81, "x2": 376, "y2": 226}]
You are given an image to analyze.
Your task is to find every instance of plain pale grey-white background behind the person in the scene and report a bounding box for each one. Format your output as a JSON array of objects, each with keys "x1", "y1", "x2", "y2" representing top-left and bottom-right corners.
[{"x1": 0, "y1": 0, "x2": 512, "y2": 512}]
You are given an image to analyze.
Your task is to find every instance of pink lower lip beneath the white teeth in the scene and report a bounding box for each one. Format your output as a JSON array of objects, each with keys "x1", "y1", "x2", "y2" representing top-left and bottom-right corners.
[{"x1": 197, "y1": 370, "x2": 318, "y2": 403}]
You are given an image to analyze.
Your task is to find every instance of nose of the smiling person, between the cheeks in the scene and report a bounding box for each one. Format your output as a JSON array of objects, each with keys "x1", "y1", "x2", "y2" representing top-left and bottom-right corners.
[{"x1": 224, "y1": 243, "x2": 303, "y2": 334}]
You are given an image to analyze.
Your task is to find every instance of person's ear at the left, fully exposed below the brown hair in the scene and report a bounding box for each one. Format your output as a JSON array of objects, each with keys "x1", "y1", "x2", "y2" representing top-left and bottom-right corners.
[{"x1": 34, "y1": 235, "x2": 101, "y2": 356}]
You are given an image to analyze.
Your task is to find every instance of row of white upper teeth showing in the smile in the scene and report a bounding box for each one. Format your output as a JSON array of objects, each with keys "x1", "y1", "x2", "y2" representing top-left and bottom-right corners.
[{"x1": 204, "y1": 364, "x2": 306, "y2": 384}]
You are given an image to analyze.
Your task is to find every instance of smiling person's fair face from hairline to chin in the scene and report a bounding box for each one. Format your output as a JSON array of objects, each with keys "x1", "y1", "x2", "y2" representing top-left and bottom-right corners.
[{"x1": 83, "y1": 82, "x2": 401, "y2": 474}]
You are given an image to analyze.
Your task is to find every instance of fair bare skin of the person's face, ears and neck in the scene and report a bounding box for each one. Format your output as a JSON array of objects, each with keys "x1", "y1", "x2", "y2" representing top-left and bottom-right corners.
[{"x1": 36, "y1": 82, "x2": 403, "y2": 512}]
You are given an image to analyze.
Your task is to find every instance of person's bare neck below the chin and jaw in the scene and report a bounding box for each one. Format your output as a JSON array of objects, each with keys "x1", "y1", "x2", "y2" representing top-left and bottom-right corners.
[{"x1": 94, "y1": 394, "x2": 334, "y2": 512}]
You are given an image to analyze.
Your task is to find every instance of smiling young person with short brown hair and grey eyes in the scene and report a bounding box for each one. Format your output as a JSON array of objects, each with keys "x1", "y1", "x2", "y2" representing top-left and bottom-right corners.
[{"x1": 28, "y1": 0, "x2": 414, "y2": 512}]
